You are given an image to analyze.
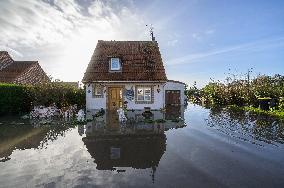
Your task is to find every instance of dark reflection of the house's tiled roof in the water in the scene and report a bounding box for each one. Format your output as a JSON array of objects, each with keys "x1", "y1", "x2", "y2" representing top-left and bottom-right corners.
[{"x1": 83, "y1": 134, "x2": 166, "y2": 170}]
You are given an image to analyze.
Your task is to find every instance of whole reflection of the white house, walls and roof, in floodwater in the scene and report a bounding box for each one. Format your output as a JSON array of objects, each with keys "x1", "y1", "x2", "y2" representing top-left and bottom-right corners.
[{"x1": 80, "y1": 107, "x2": 185, "y2": 178}]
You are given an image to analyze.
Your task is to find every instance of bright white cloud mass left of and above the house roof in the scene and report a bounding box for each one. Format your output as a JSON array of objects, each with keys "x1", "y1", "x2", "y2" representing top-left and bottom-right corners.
[{"x1": 0, "y1": 0, "x2": 147, "y2": 80}]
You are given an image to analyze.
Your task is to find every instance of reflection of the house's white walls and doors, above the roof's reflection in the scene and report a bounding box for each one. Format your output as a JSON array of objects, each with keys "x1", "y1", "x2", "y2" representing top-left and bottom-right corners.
[{"x1": 86, "y1": 106, "x2": 186, "y2": 135}]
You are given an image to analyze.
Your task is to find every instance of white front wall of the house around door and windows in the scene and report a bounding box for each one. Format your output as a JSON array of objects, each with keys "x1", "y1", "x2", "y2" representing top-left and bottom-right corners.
[{"x1": 86, "y1": 83, "x2": 165, "y2": 110}]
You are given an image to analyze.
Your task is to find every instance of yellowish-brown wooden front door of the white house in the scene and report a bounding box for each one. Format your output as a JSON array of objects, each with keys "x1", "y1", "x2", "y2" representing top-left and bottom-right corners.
[{"x1": 107, "y1": 87, "x2": 123, "y2": 110}]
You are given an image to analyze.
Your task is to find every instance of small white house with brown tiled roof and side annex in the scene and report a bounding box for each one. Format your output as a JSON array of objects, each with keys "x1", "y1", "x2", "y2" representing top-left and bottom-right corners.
[{"x1": 82, "y1": 40, "x2": 185, "y2": 110}]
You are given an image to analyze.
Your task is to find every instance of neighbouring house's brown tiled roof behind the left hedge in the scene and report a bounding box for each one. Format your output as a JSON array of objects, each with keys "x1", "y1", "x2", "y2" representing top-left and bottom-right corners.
[{"x1": 0, "y1": 51, "x2": 49, "y2": 84}]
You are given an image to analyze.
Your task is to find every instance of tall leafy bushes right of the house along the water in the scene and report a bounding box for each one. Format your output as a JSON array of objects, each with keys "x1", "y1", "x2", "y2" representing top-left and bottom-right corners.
[{"x1": 191, "y1": 75, "x2": 284, "y2": 109}]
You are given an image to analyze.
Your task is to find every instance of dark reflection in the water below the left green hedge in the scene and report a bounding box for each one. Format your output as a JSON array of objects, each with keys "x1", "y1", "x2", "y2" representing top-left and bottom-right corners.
[{"x1": 0, "y1": 121, "x2": 72, "y2": 162}]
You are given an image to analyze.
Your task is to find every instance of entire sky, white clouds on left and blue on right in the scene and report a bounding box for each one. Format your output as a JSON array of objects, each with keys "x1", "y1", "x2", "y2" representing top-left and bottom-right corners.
[{"x1": 0, "y1": 0, "x2": 284, "y2": 87}]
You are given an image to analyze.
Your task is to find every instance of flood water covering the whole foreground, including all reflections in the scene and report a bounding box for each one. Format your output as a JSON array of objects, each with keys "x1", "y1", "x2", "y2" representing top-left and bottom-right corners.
[{"x1": 0, "y1": 104, "x2": 284, "y2": 188}]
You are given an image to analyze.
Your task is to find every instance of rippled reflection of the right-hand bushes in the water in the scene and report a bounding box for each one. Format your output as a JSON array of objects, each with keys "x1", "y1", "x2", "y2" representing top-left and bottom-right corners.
[{"x1": 207, "y1": 107, "x2": 284, "y2": 144}]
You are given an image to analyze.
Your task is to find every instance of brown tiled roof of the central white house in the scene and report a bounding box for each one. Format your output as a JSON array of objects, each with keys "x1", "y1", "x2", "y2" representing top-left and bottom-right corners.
[{"x1": 83, "y1": 40, "x2": 167, "y2": 83}]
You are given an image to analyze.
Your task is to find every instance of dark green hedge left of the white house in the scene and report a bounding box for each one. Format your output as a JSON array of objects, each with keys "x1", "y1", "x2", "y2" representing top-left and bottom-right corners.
[{"x1": 0, "y1": 82, "x2": 86, "y2": 114}]
